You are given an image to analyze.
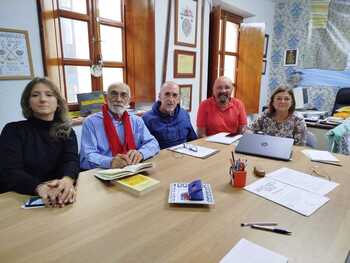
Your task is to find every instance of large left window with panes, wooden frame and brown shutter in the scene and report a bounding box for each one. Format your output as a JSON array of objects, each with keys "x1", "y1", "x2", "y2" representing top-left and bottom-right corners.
[{"x1": 38, "y1": 0, "x2": 155, "y2": 110}]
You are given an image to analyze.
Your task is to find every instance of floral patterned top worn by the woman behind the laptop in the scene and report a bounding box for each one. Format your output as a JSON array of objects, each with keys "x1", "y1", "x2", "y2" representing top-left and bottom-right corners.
[{"x1": 249, "y1": 111, "x2": 306, "y2": 145}]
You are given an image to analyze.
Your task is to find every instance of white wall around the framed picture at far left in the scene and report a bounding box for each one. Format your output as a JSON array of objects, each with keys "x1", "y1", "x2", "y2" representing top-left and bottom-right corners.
[{"x1": 0, "y1": 0, "x2": 44, "y2": 131}]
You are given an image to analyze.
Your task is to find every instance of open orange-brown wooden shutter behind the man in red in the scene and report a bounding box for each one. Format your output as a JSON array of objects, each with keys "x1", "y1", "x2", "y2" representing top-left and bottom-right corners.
[{"x1": 235, "y1": 23, "x2": 265, "y2": 113}]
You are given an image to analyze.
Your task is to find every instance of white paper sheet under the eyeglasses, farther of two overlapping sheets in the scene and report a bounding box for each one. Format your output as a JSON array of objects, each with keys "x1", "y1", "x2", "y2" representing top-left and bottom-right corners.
[{"x1": 266, "y1": 167, "x2": 338, "y2": 195}]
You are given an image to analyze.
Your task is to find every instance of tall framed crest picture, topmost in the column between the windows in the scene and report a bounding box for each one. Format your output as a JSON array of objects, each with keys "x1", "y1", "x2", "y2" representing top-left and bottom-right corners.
[{"x1": 175, "y1": 0, "x2": 198, "y2": 47}]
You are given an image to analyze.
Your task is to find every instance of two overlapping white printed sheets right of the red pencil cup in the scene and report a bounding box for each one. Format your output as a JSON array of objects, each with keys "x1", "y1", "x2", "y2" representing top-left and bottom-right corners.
[{"x1": 244, "y1": 168, "x2": 338, "y2": 216}]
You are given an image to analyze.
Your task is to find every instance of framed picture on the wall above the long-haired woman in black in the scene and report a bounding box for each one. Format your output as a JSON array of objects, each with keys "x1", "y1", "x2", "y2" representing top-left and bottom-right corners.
[{"x1": 0, "y1": 28, "x2": 34, "y2": 80}]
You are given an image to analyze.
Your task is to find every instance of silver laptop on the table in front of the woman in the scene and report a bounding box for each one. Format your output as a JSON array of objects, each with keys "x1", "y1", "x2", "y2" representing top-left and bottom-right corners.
[{"x1": 236, "y1": 133, "x2": 294, "y2": 161}]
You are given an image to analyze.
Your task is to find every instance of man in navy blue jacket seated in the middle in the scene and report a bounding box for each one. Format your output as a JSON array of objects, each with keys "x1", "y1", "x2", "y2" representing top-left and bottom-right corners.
[{"x1": 142, "y1": 81, "x2": 197, "y2": 149}]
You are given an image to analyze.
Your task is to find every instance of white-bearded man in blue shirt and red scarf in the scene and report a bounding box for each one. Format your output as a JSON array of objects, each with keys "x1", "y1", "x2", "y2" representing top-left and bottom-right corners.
[{"x1": 80, "y1": 83, "x2": 159, "y2": 169}]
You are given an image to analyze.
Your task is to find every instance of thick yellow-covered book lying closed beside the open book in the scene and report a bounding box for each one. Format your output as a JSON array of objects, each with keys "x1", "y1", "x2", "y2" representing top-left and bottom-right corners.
[{"x1": 116, "y1": 174, "x2": 159, "y2": 195}]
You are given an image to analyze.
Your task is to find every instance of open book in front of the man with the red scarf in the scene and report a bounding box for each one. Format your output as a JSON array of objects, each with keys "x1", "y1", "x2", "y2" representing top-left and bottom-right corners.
[{"x1": 95, "y1": 163, "x2": 154, "y2": 181}]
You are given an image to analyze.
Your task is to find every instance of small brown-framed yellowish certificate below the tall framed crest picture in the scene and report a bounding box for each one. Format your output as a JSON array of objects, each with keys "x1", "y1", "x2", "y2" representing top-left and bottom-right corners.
[{"x1": 174, "y1": 50, "x2": 196, "y2": 78}]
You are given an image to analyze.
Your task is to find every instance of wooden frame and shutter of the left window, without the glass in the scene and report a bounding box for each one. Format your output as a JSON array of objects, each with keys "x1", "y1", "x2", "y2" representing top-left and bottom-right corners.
[{"x1": 37, "y1": 0, "x2": 155, "y2": 111}]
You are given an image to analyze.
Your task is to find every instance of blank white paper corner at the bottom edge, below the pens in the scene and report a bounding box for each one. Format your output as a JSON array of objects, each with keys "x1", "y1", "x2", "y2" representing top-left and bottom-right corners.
[{"x1": 220, "y1": 238, "x2": 288, "y2": 263}]
